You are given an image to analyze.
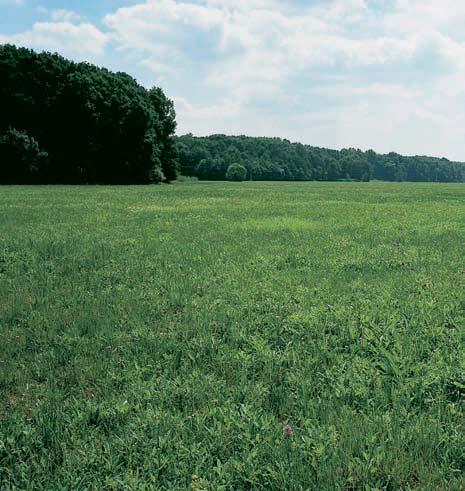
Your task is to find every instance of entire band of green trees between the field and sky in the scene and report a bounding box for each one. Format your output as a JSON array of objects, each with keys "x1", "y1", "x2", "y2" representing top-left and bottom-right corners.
[{"x1": 0, "y1": 45, "x2": 465, "y2": 184}]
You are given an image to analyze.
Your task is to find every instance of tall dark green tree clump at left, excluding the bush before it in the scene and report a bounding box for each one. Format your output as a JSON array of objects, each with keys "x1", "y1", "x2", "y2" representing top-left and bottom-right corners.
[{"x1": 0, "y1": 45, "x2": 176, "y2": 183}]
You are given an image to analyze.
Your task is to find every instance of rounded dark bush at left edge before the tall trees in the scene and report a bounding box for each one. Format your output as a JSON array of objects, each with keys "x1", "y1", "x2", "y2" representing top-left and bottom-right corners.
[{"x1": 0, "y1": 128, "x2": 47, "y2": 184}]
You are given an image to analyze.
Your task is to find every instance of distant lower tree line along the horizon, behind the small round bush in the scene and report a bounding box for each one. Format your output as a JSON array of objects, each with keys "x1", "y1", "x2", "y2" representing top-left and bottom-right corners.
[{"x1": 177, "y1": 134, "x2": 465, "y2": 182}]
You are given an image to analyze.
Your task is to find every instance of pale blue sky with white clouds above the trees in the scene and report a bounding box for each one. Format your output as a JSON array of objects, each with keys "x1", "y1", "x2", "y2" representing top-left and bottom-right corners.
[{"x1": 0, "y1": 0, "x2": 465, "y2": 161}]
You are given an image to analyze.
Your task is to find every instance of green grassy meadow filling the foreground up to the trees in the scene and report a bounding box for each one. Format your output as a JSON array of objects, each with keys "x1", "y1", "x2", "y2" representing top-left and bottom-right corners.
[{"x1": 0, "y1": 183, "x2": 465, "y2": 491}]
